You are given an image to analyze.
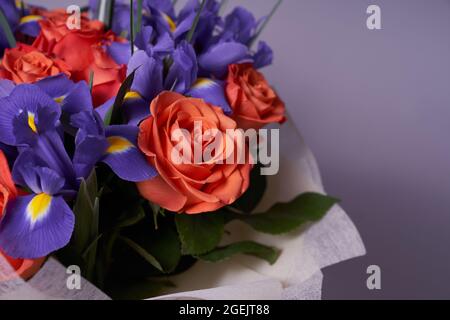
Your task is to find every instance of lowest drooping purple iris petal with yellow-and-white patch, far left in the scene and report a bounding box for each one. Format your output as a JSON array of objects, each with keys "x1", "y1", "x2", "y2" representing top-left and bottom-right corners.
[{"x1": 0, "y1": 149, "x2": 75, "y2": 259}]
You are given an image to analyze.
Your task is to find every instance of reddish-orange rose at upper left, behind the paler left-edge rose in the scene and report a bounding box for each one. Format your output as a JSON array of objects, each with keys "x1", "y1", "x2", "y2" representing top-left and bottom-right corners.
[{"x1": 33, "y1": 10, "x2": 126, "y2": 106}]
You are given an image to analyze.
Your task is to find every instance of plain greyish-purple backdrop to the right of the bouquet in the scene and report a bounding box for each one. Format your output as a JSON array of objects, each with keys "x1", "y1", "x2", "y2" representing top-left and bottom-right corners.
[{"x1": 32, "y1": 0, "x2": 450, "y2": 299}]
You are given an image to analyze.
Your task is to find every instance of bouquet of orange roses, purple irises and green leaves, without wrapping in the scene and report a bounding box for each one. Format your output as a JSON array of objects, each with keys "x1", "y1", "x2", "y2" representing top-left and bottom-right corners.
[{"x1": 0, "y1": 0, "x2": 346, "y2": 299}]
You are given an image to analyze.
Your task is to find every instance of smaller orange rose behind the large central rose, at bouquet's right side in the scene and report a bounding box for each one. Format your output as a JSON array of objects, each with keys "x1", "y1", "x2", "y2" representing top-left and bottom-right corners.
[{"x1": 225, "y1": 64, "x2": 286, "y2": 129}]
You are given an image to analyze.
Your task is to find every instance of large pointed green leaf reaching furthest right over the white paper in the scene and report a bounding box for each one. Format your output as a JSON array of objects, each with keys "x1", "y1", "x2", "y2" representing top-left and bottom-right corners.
[{"x1": 234, "y1": 193, "x2": 339, "y2": 235}]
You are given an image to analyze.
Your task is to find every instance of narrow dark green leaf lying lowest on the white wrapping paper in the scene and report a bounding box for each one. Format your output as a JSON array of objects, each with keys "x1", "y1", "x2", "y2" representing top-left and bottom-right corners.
[{"x1": 198, "y1": 241, "x2": 280, "y2": 264}]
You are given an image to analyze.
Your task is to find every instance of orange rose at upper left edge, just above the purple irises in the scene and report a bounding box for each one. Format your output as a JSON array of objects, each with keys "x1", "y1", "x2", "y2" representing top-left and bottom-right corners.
[{"x1": 1, "y1": 43, "x2": 70, "y2": 83}]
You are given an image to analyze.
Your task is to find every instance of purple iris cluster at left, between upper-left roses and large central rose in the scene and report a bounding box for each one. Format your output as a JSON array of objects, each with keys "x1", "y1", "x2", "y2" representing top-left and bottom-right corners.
[{"x1": 0, "y1": 79, "x2": 156, "y2": 259}]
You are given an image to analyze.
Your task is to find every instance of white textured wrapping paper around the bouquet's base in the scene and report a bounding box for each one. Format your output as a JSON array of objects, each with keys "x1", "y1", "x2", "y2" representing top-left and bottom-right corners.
[{"x1": 0, "y1": 121, "x2": 365, "y2": 300}]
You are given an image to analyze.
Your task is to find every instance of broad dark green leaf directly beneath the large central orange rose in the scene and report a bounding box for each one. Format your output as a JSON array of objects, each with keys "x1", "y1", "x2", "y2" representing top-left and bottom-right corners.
[{"x1": 175, "y1": 212, "x2": 225, "y2": 255}]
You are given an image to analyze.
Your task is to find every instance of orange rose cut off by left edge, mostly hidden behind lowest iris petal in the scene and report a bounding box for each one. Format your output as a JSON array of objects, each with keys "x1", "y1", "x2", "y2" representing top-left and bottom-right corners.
[{"x1": 0, "y1": 150, "x2": 45, "y2": 281}]
